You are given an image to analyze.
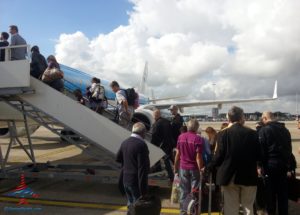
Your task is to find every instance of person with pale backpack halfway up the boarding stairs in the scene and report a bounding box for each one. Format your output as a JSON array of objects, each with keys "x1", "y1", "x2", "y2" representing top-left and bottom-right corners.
[{"x1": 88, "y1": 77, "x2": 105, "y2": 114}]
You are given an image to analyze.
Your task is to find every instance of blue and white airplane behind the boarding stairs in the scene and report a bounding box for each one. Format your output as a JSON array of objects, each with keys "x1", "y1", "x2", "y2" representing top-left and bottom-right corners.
[{"x1": 0, "y1": 63, "x2": 278, "y2": 138}]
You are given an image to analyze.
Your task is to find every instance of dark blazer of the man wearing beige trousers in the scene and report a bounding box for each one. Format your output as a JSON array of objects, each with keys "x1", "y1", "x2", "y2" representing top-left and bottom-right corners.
[{"x1": 208, "y1": 123, "x2": 261, "y2": 186}]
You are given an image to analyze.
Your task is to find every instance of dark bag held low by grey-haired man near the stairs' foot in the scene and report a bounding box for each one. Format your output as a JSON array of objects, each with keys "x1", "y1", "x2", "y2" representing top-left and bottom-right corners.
[{"x1": 128, "y1": 195, "x2": 161, "y2": 215}]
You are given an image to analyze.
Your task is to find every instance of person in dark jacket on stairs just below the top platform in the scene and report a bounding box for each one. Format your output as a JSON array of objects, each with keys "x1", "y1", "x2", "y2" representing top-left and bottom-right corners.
[{"x1": 30, "y1": 46, "x2": 48, "y2": 79}]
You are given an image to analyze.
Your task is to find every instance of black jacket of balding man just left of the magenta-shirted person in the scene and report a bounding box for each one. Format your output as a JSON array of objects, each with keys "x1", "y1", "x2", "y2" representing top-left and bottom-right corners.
[{"x1": 151, "y1": 117, "x2": 176, "y2": 156}]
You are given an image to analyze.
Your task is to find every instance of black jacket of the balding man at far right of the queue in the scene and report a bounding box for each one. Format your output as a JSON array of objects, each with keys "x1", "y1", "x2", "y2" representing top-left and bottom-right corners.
[{"x1": 259, "y1": 121, "x2": 292, "y2": 171}]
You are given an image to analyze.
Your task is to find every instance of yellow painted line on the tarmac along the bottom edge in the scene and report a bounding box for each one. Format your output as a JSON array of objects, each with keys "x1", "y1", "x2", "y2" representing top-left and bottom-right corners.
[{"x1": 0, "y1": 197, "x2": 219, "y2": 215}]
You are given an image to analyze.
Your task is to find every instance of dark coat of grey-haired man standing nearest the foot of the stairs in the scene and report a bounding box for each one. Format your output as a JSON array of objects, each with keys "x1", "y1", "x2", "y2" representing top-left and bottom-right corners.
[{"x1": 116, "y1": 137, "x2": 150, "y2": 195}]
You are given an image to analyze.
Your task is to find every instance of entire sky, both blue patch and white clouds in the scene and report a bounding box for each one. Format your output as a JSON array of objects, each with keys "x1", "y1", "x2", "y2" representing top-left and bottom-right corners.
[{"x1": 0, "y1": 0, "x2": 300, "y2": 113}]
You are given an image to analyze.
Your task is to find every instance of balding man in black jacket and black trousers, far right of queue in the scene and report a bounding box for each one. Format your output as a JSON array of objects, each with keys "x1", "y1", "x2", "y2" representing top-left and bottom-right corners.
[{"x1": 259, "y1": 112, "x2": 292, "y2": 215}]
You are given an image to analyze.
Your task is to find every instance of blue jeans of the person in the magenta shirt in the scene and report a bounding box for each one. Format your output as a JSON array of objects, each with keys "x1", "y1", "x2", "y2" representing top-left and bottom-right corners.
[{"x1": 179, "y1": 169, "x2": 200, "y2": 214}]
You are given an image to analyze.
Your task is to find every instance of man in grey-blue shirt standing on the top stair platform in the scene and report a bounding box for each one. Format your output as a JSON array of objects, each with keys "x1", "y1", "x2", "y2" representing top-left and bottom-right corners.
[{"x1": 9, "y1": 25, "x2": 27, "y2": 60}]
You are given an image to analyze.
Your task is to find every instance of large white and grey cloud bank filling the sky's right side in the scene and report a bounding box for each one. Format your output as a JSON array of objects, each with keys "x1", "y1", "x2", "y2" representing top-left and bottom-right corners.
[{"x1": 55, "y1": 0, "x2": 300, "y2": 112}]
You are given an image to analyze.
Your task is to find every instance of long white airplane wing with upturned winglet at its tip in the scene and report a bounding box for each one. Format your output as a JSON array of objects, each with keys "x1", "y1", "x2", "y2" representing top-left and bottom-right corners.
[{"x1": 142, "y1": 81, "x2": 278, "y2": 110}]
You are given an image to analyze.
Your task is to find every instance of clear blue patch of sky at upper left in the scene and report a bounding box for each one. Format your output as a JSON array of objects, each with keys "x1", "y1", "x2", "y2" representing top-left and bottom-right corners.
[{"x1": 0, "y1": 0, "x2": 132, "y2": 55}]
